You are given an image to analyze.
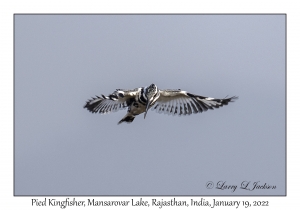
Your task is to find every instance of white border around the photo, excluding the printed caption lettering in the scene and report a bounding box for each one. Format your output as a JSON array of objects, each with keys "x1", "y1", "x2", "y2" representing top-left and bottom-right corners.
[{"x1": 0, "y1": 0, "x2": 300, "y2": 209}]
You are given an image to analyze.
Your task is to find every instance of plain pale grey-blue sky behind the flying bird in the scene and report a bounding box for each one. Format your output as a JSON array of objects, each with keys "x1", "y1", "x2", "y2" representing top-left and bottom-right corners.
[{"x1": 15, "y1": 15, "x2": 285, "y2": 195}]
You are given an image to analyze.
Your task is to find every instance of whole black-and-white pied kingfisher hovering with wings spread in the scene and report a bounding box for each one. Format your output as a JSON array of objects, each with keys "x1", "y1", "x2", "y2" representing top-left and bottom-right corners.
[{"x1": 84, "y1": 84, "x2": 238, "y2": 124}]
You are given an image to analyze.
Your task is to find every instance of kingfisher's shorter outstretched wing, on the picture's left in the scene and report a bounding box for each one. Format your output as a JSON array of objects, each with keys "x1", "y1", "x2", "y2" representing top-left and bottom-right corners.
[{"x1": 83, "y1": 88, "x2": 139, "y2": 114}]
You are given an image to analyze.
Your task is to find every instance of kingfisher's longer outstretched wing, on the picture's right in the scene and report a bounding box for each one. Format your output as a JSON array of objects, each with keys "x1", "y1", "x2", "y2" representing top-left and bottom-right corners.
[{"x1": 152, "y1": 90, "x2": 238, "y2": 115}]
